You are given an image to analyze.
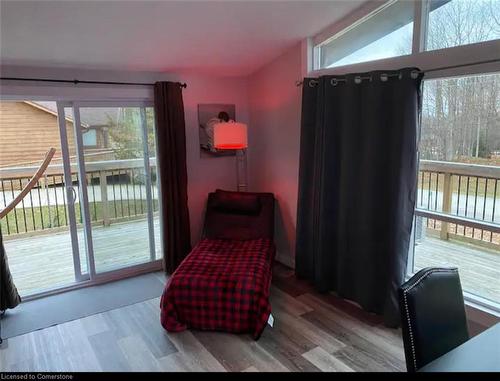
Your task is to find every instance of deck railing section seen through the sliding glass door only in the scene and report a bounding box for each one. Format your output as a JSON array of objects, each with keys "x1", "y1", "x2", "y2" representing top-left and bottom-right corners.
[{"x1": 0, "y1": 158, "x2": 158, "y2": 236}]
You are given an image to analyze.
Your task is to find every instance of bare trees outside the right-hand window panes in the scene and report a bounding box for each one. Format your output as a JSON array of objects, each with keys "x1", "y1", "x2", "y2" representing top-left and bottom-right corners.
[{"x1": 420, "y1": 0, "x2": 500, "y2": 161}]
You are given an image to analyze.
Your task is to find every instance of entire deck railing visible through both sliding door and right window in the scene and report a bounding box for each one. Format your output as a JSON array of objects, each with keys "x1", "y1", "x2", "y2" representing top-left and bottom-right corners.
[{"x1": 0, "y1": 158, "x2": 500, "y2": 247}]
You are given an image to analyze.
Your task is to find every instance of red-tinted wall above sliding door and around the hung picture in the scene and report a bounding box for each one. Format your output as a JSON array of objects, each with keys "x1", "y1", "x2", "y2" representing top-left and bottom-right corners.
[{"x1": 0, "y1": 66, "x2": 249, "y2": 243}]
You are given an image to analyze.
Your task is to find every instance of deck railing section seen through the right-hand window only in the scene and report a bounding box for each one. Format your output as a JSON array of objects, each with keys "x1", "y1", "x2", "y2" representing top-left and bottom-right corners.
[{"x1": 416, "y1": 160, "x2": 500, "y2": 246}]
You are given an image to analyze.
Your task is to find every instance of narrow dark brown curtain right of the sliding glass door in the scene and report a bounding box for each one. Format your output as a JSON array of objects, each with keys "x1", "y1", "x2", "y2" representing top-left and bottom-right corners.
[{"x1": 154, "y1": 82, "x2": 191, "y2": 274}]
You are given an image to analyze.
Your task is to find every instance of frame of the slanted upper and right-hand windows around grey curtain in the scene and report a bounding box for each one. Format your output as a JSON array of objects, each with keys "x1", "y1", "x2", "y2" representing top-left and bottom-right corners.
[{"x1": 303, "y1": 0, "x2": 500, "y2": 316}]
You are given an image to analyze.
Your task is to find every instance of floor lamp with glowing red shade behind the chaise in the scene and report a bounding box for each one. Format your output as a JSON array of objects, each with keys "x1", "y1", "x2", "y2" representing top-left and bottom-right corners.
[{"x1": 214, "y1": 122, "x2": 248, "y2": 192}]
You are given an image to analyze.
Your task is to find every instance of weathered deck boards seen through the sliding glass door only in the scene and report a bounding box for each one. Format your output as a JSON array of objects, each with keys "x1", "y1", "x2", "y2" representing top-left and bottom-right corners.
[{"x1": 4, "y1": 218, "x2": 161, "y2": 296}]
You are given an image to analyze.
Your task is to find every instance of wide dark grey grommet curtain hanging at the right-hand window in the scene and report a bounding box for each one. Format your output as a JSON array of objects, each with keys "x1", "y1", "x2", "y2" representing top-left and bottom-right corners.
[{"x1": 296, "y1": 68, "x2": 422, "y2": 326}]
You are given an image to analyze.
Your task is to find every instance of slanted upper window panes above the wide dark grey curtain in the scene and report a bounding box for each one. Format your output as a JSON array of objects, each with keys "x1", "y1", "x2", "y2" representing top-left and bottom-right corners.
[{"x1": 314, "y1": 0, "x2": 500, "y2": 70}]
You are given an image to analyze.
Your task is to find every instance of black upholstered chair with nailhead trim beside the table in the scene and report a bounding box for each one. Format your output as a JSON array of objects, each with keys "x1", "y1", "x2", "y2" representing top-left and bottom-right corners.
[{"x1": 399, "y1": 268, "x2": 469, "y2": 372}]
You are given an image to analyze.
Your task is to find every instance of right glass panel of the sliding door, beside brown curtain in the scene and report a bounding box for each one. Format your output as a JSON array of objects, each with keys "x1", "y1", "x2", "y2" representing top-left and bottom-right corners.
[{"x1": 77, "y1": 104, "x2": 157, "y2": 273}]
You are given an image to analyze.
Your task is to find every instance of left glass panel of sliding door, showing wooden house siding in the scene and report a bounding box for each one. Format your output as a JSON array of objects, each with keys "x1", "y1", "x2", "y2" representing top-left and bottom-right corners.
[{"x1": 0, "y1": 101, "x2": 82, "y2": 297}]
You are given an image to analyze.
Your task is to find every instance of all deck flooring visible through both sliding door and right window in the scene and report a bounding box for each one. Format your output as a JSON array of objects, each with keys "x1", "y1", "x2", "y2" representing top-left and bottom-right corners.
[{"x1": 5, "y1": 219, "x2": 500, "y2": 303}]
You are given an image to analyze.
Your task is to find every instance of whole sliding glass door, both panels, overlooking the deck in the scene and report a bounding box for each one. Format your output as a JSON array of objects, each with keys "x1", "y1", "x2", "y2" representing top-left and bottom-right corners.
[{"x1": 0, "y1": 102, "x2": 161, "y2": 298}]
